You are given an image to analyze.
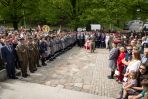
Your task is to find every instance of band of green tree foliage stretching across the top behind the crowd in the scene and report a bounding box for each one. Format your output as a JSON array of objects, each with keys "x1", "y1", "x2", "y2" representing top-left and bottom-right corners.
[{"x1": 0, "y1": 0, "x2": 148, "y2": 28}]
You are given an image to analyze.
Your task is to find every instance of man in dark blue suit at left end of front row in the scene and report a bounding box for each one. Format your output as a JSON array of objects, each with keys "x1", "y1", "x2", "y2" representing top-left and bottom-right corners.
[{"x1": 1, "y1": 39, "x2": 17, "y2": 79}]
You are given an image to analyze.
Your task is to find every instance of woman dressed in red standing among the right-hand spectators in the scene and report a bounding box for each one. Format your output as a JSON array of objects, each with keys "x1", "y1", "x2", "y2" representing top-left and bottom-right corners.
[{"x1": 116, "y1": 47, "x2": 126, "y2": 83}]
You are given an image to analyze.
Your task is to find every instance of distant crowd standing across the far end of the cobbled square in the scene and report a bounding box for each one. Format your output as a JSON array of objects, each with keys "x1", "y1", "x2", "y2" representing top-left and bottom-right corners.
[{"x1": 77, "y1": 31, "x2": 128, "y2": 52}]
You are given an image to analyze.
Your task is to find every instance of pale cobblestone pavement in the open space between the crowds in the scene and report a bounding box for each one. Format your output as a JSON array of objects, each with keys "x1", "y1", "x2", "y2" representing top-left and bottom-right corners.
[{"x1": 21, "y1": 47, "x2": 121, "y2": 98}]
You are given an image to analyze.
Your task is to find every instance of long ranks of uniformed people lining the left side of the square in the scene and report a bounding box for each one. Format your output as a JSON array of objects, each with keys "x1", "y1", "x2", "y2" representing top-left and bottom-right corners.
[{"x1": 0, "y1": 26, "x2": 76, "y2": 79}]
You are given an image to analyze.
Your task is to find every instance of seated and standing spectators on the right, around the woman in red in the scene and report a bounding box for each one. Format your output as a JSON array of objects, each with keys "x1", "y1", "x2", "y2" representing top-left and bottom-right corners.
[{"x1": 108, "y1": 34, "x2": 148, "y2": 99}]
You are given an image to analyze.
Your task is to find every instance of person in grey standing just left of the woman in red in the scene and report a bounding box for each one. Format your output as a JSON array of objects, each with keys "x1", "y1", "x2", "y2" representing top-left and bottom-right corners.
[{"x1": 108, "y1": 43, "x2": 119, "y2": 79}]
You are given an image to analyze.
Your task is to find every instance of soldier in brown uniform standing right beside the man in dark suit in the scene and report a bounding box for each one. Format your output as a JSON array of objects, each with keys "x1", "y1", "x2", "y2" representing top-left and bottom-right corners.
[{"x1": 16, "y1": 38, "x2": 29, "y2": 78}]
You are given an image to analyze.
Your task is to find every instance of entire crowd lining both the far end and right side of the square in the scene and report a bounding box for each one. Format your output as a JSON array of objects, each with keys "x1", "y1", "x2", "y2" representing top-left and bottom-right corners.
[{"x1": 77, "y1": 32, "x2": 148, "y2": 99}]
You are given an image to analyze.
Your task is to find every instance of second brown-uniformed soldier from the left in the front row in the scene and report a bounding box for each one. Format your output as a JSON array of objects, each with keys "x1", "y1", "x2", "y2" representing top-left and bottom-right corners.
[{"x1": 27, "y1": 37, "x2": 37, "y2": 73}]
